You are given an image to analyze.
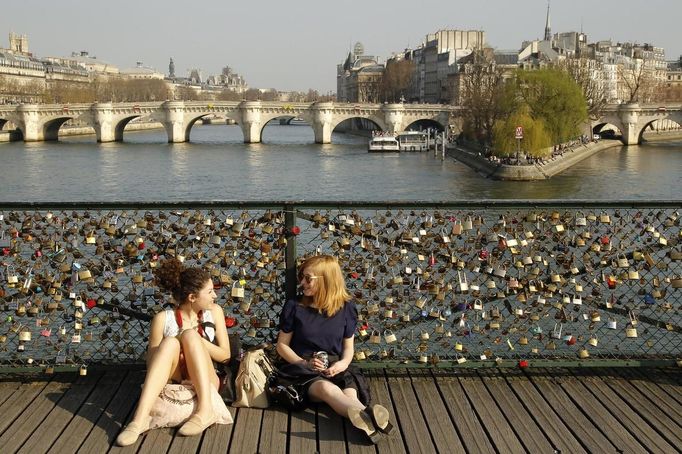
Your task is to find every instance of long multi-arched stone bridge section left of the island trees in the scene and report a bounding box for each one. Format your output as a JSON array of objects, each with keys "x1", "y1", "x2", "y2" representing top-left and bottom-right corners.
[{"x1": 0, "y1": 101, "x2": 459, "y2": 143}]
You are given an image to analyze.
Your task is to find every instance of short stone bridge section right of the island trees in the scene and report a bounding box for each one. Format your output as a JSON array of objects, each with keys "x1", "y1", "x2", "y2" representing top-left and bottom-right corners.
[{"x1": 592, "y1": 103, "x2": 682, "y2": 145}]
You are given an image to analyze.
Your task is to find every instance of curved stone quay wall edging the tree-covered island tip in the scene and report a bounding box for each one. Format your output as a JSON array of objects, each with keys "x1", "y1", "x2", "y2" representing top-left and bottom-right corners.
[{"x1": 446, "y1": 140, "x2": 623, "y2": 181}]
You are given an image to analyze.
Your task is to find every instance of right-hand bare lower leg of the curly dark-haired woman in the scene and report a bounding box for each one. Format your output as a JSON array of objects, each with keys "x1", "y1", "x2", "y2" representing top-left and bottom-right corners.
[{"x1": 180, "y1": 330, "x2": 218, "y2": 420}]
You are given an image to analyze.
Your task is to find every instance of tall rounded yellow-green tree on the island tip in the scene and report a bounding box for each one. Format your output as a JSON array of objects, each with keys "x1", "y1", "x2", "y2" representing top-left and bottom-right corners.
[{"x1": 515, "y1": 69, "x2": 588, "y2": 143}]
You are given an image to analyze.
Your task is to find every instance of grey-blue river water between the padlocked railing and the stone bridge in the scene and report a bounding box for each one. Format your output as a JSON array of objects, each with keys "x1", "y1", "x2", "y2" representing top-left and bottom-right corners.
[{"x1": 0, "y1": 125, "x2": 682, "y2": 202}]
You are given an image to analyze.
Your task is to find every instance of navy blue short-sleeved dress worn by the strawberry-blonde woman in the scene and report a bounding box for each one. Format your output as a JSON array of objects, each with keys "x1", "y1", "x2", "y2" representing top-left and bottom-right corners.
[{"x1": 279, "y1": 300, "x2": 370, "y2": 405}]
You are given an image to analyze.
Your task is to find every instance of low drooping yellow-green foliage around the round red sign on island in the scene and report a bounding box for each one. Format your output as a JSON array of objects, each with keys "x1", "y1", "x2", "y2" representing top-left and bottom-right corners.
[{"x1": 493, "y1": 107, "x2": 552, "y2": 157}]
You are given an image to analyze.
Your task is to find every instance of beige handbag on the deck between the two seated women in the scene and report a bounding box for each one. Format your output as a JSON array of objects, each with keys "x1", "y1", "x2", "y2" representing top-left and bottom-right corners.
[{"x1": 232, "y1": 347, "x2": 274, "y2": 408}]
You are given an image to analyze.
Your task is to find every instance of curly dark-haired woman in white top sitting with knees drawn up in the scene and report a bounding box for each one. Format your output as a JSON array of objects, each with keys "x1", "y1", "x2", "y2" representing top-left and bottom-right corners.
[{"x1": 116, "y1": 258, "x2": 230, "y2": 446}]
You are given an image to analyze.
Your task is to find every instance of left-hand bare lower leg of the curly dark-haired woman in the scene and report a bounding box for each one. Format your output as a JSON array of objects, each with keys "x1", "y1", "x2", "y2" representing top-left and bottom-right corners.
[{"x1": 131, "y1": 337, "x2": 180, "y2": 427}]
